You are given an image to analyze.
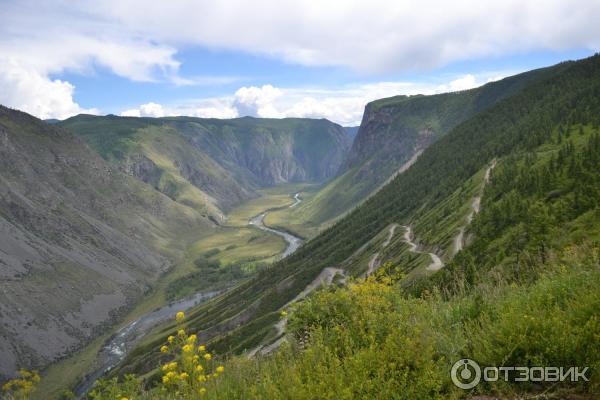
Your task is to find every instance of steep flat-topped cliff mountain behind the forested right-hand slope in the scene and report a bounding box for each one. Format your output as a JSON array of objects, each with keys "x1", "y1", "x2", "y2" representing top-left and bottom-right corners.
[{"x1": 290, "y1": 63, "x2": 569, "y2": 230}]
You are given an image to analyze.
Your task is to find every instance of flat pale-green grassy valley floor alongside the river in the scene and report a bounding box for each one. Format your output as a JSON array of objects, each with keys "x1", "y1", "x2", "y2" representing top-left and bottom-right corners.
[{"x1": 36, "y1": 184, "x2": 314, "y2": 399}]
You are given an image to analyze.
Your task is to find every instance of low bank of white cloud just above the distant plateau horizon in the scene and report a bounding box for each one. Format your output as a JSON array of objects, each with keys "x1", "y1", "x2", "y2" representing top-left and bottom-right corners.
[{"x1": 121, "y1": 74, "x2": 502, "y2": 126}]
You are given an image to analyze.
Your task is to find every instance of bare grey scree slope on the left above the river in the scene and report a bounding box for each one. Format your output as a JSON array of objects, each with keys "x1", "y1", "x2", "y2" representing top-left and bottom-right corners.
[{"x1": 0, "y1": 106, "x2": 213, "y2": 382}]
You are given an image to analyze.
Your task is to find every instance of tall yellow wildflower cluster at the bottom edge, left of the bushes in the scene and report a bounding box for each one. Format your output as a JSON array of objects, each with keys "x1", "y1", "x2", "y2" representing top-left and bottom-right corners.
[{"x1": 160, "y1": 312, "x2": 225, "y2": 395}]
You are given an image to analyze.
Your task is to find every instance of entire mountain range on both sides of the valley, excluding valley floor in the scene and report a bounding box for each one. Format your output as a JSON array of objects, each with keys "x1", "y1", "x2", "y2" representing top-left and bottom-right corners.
[{"x1": 0, "y1": 55, "x2": 600, "y2": 399}]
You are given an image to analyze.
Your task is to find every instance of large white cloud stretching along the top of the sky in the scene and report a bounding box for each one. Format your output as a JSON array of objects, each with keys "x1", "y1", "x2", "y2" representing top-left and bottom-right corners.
[{"x1": 79, "y1": 0, "x2": 600, "y2": 72}]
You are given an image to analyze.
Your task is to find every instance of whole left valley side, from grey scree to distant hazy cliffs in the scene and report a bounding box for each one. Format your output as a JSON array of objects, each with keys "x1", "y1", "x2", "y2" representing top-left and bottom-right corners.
[{"x1": 0, "y1": 107, "x2": 351, "y2": 388}]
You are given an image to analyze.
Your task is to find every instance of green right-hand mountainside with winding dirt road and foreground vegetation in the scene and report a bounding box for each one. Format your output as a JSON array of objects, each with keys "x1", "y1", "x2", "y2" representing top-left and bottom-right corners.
[{"x1": 100, "y1": 55, "x2": 600, "y2": 398}]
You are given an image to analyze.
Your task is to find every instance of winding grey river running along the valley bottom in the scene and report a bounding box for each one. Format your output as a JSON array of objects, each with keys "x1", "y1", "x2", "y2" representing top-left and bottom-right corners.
[{"x1": 74, "y1": 193, "x2": 302, "y2": 399}]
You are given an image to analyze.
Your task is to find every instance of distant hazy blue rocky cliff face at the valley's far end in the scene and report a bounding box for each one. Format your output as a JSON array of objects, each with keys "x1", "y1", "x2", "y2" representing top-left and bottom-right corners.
[{"x1": 172, "y1": 117, "x2": 351, "y2": 187}]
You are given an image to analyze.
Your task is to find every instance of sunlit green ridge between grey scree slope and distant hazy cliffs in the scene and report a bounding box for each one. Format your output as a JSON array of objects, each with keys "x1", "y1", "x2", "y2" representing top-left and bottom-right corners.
[{"x1": 60, "y1": 115, "x2": 252, "y2": 219}]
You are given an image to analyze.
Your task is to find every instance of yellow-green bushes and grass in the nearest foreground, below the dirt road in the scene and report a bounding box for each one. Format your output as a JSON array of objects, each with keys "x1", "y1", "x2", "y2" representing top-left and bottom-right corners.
[{"x1": 85, "y1": 244, "x2": 600, "y2": 400}]
